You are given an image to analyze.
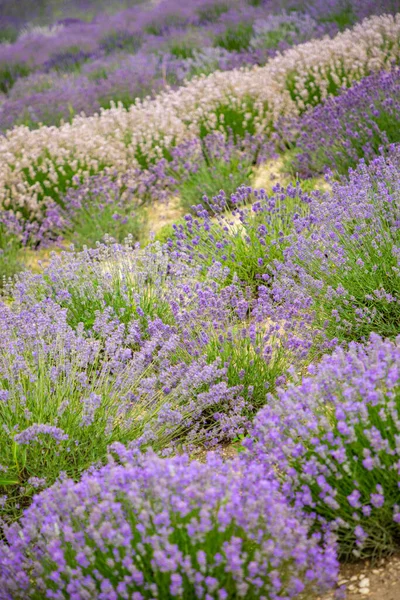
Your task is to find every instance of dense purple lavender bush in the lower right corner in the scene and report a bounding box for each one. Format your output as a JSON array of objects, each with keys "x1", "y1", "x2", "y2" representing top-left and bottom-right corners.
[{"x1": 247, "y1": 334, "x2": 400, "y2": 557}]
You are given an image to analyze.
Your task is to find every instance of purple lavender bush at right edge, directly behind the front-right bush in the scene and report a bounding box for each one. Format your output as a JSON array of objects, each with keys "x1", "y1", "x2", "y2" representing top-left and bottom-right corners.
[{"x1": 255, "y1": 146, "x2": 400, "y2": 348}]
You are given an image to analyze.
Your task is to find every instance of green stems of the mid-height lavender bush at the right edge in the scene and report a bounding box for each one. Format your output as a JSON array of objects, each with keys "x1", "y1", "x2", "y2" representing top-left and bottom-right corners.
[{"x1": 295, "y1": 182, "x2": 400, "y2": 342}]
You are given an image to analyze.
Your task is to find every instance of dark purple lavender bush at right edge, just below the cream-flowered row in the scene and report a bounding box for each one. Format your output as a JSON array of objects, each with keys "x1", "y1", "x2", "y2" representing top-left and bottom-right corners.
[{"x1": 279, "y1": 68, "x2": 400, "y2": 177}]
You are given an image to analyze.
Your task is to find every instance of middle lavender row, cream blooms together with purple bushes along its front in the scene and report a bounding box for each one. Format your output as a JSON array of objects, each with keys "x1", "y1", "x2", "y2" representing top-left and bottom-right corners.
[{"x1": 0, "y1": 15, "x2": 400, "y2": 255}]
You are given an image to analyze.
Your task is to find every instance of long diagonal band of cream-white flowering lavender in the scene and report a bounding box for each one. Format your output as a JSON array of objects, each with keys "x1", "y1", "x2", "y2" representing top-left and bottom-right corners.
[{"x1": 0, "y1": 14, "x2": 400, "y2": 218}]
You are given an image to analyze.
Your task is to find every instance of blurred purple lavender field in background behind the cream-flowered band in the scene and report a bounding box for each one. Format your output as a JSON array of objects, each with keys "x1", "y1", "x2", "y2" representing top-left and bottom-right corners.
[{"x1": 0, "y1": 0, "x2": 397, "y2": 131}]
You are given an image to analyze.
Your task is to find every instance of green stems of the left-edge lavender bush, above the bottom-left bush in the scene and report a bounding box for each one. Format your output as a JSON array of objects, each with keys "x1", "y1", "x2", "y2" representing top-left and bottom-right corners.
[{"x1": 0, "y1": 348, "x2": 166, "y2": 521}]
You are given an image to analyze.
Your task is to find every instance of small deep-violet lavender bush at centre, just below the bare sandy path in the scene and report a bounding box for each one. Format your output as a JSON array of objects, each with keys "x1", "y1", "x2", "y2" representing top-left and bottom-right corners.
[{"x1": 167, "y1": 185, "x2": 311, "y2": 292}]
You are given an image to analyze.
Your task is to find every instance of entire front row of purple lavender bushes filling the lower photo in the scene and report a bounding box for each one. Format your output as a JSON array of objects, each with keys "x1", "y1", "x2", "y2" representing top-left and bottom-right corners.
[{"x1": 0, "y1": 146, "x2": 400, "y2": 600}]
